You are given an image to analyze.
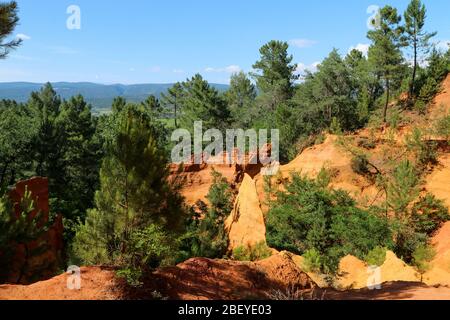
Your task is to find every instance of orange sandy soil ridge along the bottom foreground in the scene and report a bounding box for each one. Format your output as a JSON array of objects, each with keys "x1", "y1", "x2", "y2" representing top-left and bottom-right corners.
[{"x1": 0, "y1": 255, "x2": 450, "y2": 300}]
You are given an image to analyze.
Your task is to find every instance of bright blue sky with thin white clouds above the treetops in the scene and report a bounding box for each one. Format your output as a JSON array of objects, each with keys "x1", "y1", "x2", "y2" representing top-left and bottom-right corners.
[{"x1": 0, "y1": 0, "x2": 450, "y2": 84}]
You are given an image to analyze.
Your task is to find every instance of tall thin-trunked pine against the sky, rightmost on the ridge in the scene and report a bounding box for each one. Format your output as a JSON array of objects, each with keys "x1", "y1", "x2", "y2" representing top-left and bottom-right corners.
[{"x1": 404, "y1": 0, "x2": 437, "y2": 103}]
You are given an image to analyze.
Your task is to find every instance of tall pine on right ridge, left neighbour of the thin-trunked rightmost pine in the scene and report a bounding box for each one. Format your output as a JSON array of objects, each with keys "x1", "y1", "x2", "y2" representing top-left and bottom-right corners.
[{"x1": 367, "y1": 6, "x2": 403, "y2": 123}]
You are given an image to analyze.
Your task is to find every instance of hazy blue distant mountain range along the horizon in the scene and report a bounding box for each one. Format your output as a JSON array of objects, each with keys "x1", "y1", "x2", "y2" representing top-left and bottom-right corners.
[{"x1": 0, "y1": 82, "x2": 228, "y2": 111}]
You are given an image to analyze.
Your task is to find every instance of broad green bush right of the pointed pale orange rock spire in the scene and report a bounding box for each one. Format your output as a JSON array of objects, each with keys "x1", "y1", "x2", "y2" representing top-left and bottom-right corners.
[{"x1": 266, "y1": 175, "x2": 390, "y2": 273}]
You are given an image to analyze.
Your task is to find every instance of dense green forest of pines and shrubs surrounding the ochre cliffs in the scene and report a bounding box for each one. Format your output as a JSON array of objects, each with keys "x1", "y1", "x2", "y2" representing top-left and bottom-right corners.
[{"x1": 0, "y1": 0, "x2": 450, "y2": 284}]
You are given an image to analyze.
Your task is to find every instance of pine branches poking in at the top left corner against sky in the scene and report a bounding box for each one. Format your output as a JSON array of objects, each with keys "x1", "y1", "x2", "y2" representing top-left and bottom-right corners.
[{"x1": 0, "y1": 1, "x2": 22, "y2": 59}]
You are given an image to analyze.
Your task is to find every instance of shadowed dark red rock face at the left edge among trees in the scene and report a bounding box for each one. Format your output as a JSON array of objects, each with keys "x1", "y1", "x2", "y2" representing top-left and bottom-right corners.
[{"x1": 0, "y1": 178, "x2": 63, "y2": 284}]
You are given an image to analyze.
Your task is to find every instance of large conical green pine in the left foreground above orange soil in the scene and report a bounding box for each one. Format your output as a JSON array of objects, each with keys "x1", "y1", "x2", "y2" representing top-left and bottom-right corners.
[{"x1": 73, "y1": 105, "x2": 183, "y2": 274}]
